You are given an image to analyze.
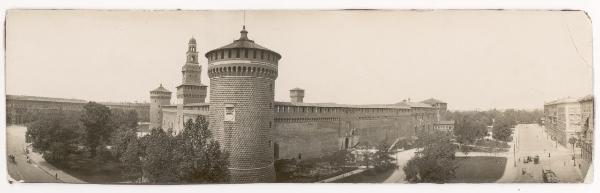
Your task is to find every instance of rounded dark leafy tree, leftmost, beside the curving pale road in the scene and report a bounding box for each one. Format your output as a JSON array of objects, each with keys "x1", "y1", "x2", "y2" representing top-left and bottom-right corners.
[{"x1": 26, "y1": 112, "x2": 81, "y2": 163}]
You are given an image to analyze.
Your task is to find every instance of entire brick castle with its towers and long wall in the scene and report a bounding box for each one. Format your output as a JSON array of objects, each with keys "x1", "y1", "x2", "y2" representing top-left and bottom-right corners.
[{"x1": 149, "y1": 27, "x2": 453, "y2": 183}]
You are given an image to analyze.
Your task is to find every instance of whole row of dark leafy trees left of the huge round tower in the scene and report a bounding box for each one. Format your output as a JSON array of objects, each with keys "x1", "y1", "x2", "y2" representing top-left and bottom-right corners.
[{"x1": 26, "y1": 102, "x2": 228, "y2": 183}]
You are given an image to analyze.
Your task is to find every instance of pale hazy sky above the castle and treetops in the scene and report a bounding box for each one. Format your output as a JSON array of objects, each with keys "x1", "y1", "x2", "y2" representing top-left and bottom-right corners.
[{"x1": 6, "y1": 10, "x2": 593, "y2": 109}]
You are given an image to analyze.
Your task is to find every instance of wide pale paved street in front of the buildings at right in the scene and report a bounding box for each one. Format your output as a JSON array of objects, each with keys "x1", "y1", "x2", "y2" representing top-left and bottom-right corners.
[{"x1": 498, "y1": 124, "x2": 583, "y2": 183}]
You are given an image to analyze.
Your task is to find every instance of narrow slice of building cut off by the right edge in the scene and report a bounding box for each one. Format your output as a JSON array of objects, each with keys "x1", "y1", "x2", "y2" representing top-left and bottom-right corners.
[{"x1": 579, "y1": 95, "x2": 594, "y2": 162}]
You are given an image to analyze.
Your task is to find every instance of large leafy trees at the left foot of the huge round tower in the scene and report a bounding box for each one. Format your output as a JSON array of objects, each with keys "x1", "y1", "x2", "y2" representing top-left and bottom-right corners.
[{"x1": 138, "y1": 116, "x2": 229, "y2": 183}]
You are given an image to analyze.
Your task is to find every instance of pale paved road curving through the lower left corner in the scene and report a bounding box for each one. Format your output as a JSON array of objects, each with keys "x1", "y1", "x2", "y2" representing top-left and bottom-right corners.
[{"x1": 6, "y1": 126, "x2": 84, "y2": 183}]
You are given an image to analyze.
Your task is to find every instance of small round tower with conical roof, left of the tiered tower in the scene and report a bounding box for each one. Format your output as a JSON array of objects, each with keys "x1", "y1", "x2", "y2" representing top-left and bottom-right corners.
[{"x1": 150, "y1": 84, "x2": 171, "y2": 129}]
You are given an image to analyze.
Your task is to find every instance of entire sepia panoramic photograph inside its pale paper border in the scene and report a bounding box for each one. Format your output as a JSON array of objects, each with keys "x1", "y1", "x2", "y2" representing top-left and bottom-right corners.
[{"x1": 3, "y1": 9, "x2": 595, "y2": 185}]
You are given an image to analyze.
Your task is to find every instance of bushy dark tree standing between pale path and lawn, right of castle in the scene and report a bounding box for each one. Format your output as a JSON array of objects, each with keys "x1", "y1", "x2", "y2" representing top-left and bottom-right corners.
[{"x1": 402, "y1": 131, "x2": 457, "y2": 183}]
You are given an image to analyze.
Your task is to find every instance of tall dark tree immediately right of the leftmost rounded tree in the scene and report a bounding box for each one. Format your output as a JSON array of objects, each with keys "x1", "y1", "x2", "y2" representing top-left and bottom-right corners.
[{"x1": 81, "y1": 102, "x2": 113, "y2": 157}]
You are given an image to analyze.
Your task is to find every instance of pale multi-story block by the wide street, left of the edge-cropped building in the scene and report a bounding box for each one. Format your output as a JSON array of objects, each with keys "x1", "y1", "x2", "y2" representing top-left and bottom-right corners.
[{"x1": 544, "y1": 98, "x2": 581, "y2": 147}]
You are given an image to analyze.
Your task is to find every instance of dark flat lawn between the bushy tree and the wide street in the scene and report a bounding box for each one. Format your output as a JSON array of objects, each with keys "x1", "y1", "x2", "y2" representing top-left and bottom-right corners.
[{"x1": 450, "y1": 157, "x2": 506, "y2": 183}]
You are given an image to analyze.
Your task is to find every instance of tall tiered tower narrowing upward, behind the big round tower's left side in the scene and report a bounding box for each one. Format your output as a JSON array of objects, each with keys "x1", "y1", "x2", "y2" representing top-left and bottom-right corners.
[{"x1": 177, "y1": 38, "x2": 207, "y2": 104}]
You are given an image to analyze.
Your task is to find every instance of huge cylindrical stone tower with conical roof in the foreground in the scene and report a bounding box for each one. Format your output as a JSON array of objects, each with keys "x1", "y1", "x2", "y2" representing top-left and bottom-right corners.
[{"x1": 205, "y1": 27, "x2": 281, "y2": 183}]
